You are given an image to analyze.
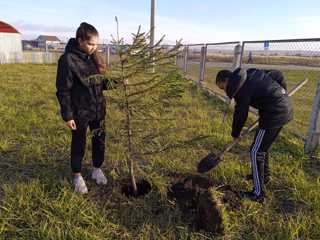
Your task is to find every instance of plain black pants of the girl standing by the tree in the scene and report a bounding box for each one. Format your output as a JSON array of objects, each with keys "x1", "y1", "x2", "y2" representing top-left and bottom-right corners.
[{"x1": 71, "y1": 120, "x2": 105, "y2": 173}]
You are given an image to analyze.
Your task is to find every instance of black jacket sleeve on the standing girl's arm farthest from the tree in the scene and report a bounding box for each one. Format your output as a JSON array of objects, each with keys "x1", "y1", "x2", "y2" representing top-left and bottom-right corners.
[{"x1": 56, "y1": 57, "x2": 73, "y2": 122}]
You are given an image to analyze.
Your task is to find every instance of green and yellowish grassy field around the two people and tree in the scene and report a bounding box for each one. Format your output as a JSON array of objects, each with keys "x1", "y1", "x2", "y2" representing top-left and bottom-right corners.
[{"x1": 0, "y1": 65, "x2": 320, "y2": 240}]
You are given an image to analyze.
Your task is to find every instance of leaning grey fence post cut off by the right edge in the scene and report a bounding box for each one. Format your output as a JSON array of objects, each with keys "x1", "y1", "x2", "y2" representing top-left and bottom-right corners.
[{"x1": 304, "y1": 80, "x2": 320, "y2": 153}]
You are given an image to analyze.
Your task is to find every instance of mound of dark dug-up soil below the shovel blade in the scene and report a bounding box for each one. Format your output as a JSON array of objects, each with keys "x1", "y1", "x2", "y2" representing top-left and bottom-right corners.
[{"x1": 168, "y1": 175, "x2": 242, "y2": 235}]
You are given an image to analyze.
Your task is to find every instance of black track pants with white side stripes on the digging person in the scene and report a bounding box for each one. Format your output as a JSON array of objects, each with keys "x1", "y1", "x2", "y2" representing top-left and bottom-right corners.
[{"x1": 250, "y1": 128, "x2": 282, "y2": 196}]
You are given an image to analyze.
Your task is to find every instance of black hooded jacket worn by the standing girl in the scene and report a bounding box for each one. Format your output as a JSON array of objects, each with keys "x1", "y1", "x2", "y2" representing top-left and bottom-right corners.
[{"x1": 56, "y1": 38, "x2": 116, "y2": 121}]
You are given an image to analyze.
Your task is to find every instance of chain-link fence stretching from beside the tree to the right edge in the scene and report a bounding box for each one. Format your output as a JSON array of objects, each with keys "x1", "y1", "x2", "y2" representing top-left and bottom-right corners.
[{"x1": 179, "y1": 39, "x2": 320, "y2": 146}]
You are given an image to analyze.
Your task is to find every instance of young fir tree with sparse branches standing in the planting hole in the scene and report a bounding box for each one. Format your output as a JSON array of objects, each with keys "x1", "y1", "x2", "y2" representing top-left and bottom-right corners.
[{"x1": 99, "y1": 19, "x2": 200, "y2": 194}]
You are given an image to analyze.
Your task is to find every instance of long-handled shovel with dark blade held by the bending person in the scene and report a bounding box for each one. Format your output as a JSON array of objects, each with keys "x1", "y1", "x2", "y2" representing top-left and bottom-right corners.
[{"x1": 198, "y1": 78, "x2": 308, "y2": 173}]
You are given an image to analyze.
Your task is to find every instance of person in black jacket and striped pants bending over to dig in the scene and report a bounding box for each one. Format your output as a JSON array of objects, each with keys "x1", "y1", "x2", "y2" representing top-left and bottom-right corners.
[{"x1": 216, "y1": 68, "x2": 293, "y2": 203}]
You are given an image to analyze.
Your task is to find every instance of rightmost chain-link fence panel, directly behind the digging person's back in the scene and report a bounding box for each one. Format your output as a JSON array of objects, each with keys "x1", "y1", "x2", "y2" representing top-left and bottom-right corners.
[{"x1": 241, "y1": 39, "x2": 320, "y2": 141}]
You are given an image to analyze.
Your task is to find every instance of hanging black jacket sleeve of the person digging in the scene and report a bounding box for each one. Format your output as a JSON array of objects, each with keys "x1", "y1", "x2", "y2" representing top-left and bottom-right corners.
[{"x1": 231, "y1": 96, "x2": 250, "y2": 137}]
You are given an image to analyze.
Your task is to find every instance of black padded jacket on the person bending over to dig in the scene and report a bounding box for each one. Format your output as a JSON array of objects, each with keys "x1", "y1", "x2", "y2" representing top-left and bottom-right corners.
[{"x1": 226, "y1": 68, "x2": 293, "y2": 137}]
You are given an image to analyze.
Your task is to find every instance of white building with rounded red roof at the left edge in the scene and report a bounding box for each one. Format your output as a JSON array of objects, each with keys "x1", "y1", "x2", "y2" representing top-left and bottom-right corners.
[{"x1": 0, "y1": 21, "x2": 22, "y2": 63}]
